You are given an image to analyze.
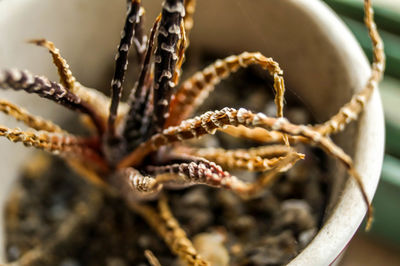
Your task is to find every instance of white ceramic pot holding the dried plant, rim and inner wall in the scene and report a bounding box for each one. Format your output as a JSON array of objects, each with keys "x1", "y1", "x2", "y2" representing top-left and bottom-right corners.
[{"x1": 0, "y1": 0, "x2": 384, "y2": 265}]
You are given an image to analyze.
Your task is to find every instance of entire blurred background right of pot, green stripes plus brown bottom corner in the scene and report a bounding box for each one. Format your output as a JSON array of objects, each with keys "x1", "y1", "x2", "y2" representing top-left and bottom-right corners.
[{"x1": 324, "y1": 0, "x2": 400, "y2": 266}]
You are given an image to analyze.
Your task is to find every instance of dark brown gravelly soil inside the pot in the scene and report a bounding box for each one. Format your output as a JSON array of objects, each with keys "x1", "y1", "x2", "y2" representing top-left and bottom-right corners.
[{"x1": 5, "y1": 50, "x2": 329, "y2": 266}]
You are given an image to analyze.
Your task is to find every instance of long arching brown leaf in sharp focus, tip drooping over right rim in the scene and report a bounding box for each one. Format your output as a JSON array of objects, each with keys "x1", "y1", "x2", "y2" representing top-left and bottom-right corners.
[{"x1": 118, "y1": 108, "x2": 372, "y2": 227}]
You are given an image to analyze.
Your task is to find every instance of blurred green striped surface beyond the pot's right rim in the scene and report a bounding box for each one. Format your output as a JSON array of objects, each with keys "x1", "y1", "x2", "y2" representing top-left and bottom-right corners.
[{"x1": 324, "y1": 0, "x2": 400, "y2": 244}]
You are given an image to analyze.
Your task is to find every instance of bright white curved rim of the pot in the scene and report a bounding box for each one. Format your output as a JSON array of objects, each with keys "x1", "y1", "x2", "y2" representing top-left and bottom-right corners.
[{"x1": 288, "y1": 0, "x2": 385, "y2": 266}]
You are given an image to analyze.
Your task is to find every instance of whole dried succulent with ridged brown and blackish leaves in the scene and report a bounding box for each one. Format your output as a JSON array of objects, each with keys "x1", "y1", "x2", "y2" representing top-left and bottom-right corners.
[{"x1": 0, "y1": 0, "x2": 385, "y2": 265}]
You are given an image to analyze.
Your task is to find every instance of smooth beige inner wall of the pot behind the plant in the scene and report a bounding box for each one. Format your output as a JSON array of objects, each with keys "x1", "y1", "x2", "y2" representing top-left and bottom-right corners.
[{"x1": 0, "y1": 0, "x2": 376, "y2": 262}]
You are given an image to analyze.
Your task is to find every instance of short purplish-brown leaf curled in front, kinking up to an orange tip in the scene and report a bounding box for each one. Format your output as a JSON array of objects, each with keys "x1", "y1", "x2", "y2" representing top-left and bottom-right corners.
[{"x1": 111, "y1": 149, "x2": 298, "y2": 202}]
